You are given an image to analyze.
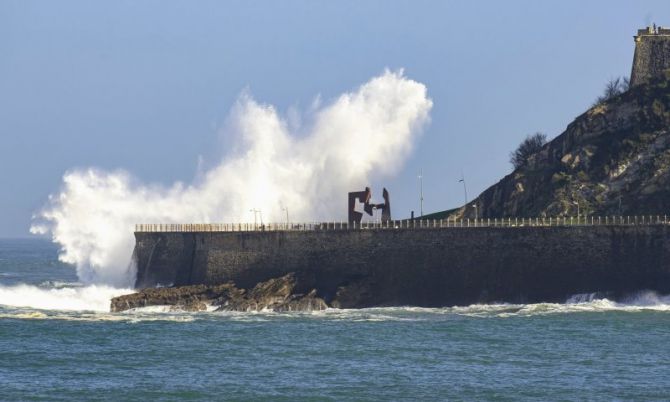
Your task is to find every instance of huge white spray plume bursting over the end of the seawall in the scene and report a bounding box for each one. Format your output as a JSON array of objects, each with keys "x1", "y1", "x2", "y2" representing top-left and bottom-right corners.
[{"x1": 31, "y1": 70, "x2": 432, "y2": 287}]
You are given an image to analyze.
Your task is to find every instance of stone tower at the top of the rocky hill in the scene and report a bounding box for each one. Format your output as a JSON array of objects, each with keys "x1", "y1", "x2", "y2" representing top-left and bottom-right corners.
[{"x1": 630, "y1": 25, "x2": 670, "y2": 86}]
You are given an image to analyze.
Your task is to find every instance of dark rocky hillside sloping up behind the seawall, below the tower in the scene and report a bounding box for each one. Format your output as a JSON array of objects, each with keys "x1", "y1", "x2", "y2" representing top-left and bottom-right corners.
[{"x1": 460, "y1": 72, "x2": 670, "y2": 218}]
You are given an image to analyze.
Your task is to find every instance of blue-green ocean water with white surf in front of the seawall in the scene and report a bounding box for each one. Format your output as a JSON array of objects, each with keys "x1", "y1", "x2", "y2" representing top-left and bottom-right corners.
[{"x1": 0, "y1": 240, "x2": 670, "y2": 401}]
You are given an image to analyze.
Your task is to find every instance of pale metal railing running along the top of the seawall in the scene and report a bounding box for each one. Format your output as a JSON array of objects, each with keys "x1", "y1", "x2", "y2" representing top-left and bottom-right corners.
[{"x1": 135, "y1": 215, "x2": 668, "y2": 232}]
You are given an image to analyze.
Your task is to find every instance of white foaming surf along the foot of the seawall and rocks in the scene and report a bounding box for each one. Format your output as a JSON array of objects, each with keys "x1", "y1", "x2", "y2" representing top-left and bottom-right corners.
[{"x1": 0, "y1": 281, "x2": 670, "y2": 322}]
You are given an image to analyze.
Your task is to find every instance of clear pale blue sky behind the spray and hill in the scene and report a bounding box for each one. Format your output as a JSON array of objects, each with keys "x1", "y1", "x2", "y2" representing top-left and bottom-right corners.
[{"x1": 0, "y1": 0, "x2": 670, "y2": 237}]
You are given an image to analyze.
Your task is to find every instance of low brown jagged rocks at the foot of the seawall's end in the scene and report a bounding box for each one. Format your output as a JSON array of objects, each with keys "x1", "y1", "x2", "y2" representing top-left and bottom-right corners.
[{"x1": 110, "y1": 273, "x2": 328, "y2": 312}]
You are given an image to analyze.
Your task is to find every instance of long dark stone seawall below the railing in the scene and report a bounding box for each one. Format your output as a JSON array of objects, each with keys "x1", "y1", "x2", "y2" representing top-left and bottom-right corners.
[{"x1": 134, "y1": 225, "x2": 670, "y2": 307}]
